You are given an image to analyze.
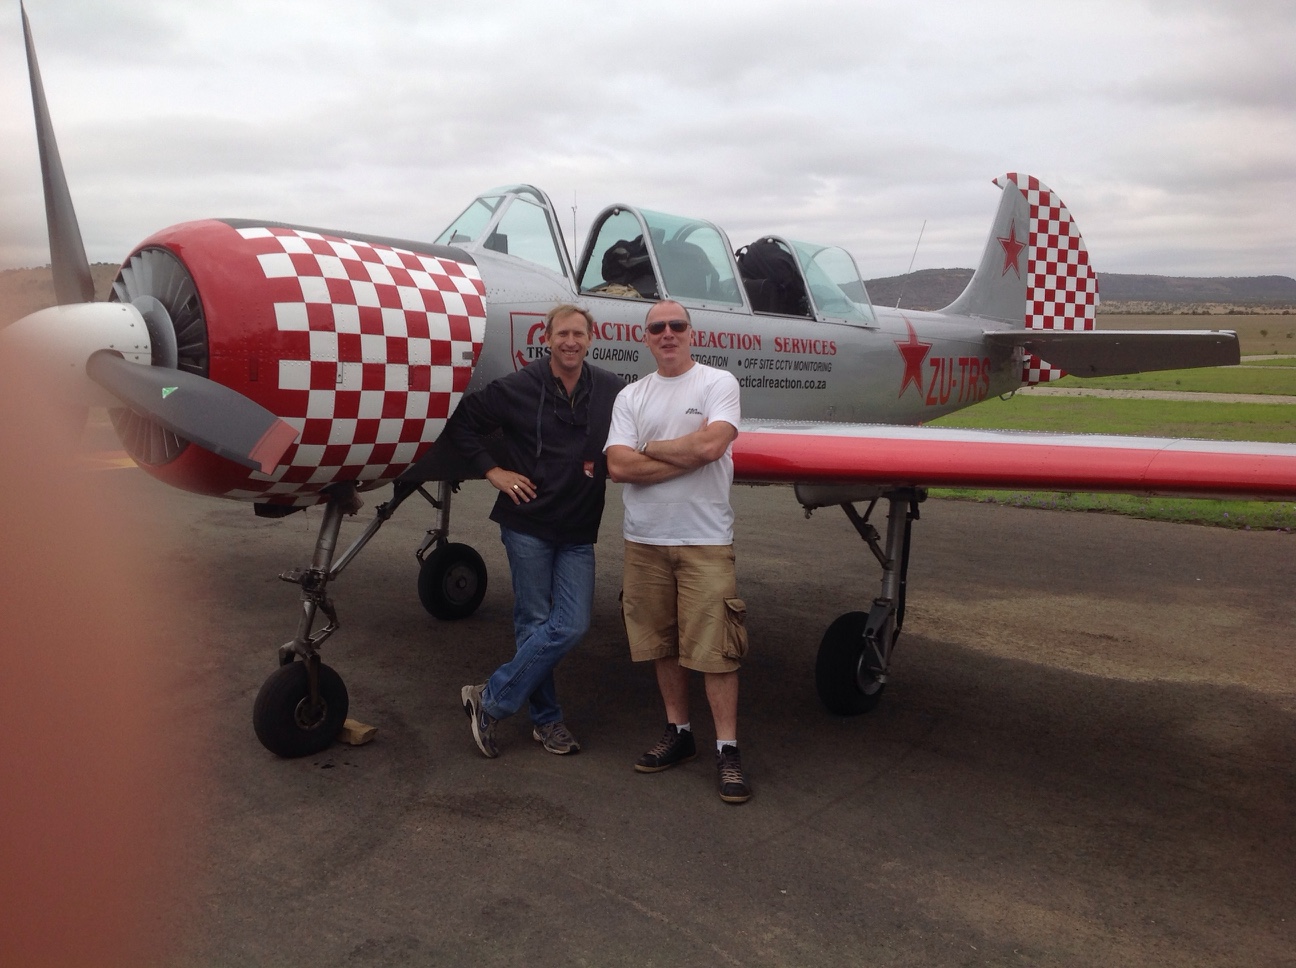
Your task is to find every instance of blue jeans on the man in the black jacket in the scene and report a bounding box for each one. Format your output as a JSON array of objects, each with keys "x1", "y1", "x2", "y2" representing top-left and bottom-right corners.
[{"x1": 482, "y1": 526, "x2": 594, "y2": 726}]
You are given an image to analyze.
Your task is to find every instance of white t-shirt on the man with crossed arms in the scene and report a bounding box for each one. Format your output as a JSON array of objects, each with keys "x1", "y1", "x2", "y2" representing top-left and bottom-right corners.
[{"x1": 604, "y1": 363, "x2": 741, "y2": 544}]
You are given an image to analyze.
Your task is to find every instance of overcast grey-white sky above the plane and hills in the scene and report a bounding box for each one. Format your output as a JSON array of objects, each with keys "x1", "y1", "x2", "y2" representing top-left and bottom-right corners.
[{"x1": 0, "y1": 0, "x2": 1296, "y2": 277}]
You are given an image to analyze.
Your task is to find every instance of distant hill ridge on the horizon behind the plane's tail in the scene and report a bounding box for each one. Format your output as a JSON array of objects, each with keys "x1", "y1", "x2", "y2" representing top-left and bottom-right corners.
[{"x1": 866, "y1": 268, "x2": 1296, "y2": 312}]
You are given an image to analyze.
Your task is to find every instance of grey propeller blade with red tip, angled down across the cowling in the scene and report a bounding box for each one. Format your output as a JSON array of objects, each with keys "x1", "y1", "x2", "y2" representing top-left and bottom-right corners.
[{"x1": 86, "y1": 350, "x2": 297, "y2": 474}]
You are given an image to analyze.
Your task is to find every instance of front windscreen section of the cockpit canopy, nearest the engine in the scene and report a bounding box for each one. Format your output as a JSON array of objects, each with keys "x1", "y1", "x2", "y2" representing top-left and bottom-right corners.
[{"x1": 437, "y1": 185, "x2": 572, "y2": 279}]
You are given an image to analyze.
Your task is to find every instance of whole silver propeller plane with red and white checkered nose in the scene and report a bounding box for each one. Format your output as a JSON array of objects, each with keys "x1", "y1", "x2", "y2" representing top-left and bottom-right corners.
[{"x1": 5, "y1": 5, "x2": 1296, "y2": 755}]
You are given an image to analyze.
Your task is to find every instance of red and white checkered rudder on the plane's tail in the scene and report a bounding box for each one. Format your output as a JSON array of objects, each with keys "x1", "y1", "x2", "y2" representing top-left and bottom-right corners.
[{"x1": 995, "y1": 172, "x2": 1098, "y2": 385}]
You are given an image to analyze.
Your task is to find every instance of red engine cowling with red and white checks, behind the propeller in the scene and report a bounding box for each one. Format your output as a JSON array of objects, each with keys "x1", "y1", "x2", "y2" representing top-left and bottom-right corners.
[{"x1": 127, "y1": 220, "x2": 486, "y2": 505}]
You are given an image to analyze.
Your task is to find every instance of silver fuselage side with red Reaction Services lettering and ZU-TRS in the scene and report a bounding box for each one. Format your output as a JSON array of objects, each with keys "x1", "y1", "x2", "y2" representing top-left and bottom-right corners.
[{"x1": 469, "y1": 254, "x2": 1020, "y2": 424}]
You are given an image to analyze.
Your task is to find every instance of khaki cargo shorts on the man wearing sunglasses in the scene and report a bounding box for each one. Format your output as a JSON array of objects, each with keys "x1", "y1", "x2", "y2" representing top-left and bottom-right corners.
[{"x1": 621, "y1": 542, "x2": 746, "y2": 673}]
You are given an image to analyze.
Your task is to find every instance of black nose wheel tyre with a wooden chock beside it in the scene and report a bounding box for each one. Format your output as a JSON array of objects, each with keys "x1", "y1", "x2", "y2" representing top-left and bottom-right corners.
[{"x1": 251, "y1": 662, "x2": 350, "y2": 759}]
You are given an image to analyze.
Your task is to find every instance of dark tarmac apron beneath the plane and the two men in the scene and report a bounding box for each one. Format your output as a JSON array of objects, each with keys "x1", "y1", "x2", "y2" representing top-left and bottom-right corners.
[{"x1": 96, "y1": 470, "x2": 1296, "y2": 968}]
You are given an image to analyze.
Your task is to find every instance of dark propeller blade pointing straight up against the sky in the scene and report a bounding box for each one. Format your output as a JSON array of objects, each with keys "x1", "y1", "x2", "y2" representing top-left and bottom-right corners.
[{"x1": 19, "y1": 5, "x2": 95, "y2": 305}]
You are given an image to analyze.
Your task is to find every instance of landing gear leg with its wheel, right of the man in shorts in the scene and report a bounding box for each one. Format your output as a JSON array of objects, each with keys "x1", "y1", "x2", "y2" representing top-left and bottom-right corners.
[{"x1": 798, "y1": 487, "x2": 927, "y2": 715}]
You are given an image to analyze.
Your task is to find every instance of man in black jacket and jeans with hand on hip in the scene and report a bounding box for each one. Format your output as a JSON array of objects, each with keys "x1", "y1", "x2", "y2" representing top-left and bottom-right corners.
[{"x1": 445, "y1": 305, "x2": 622, "y2": 757}]
